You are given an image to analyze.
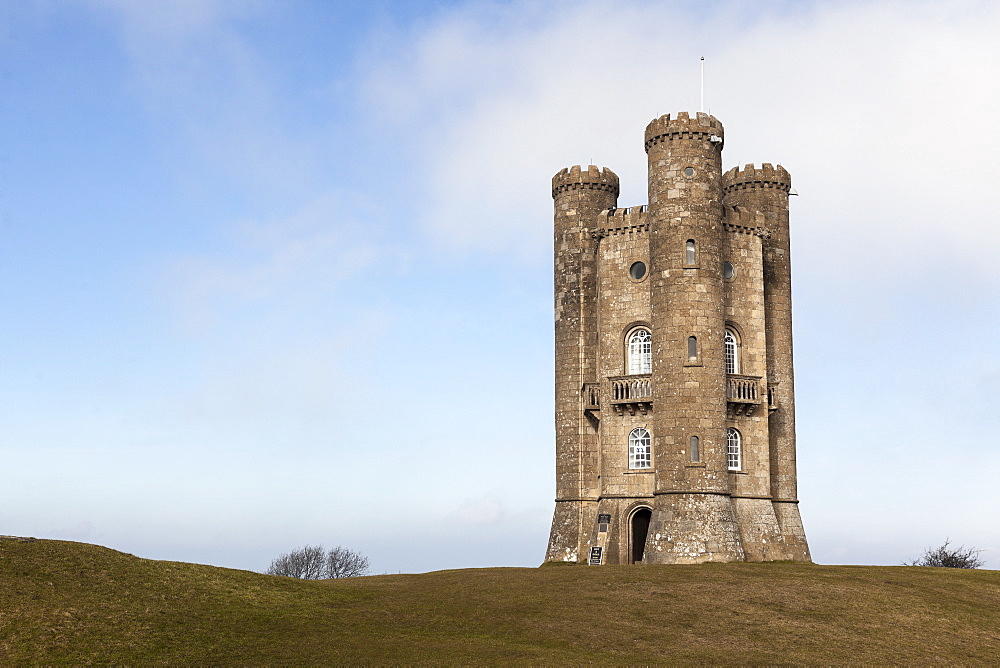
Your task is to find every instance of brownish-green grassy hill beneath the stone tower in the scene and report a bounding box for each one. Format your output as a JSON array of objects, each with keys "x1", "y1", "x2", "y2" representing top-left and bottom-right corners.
[{"x1": 0, "y1": 539, "x2": 1000, "y2": 665}]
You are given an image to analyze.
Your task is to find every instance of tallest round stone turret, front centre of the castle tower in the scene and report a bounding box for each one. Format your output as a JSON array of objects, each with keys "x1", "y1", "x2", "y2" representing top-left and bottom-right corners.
[{"x1": 645, "y1": 112, "x2": 744, "y2": 548}]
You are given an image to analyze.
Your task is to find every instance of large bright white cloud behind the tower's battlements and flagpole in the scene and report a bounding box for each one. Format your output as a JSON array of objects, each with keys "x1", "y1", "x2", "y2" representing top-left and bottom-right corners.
[{"x1": 367, "y1": 2, "x2": 1000, "y2": 274}]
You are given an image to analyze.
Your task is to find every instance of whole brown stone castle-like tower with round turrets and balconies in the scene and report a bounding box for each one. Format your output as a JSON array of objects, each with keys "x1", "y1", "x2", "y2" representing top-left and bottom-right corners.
[{"x1": 546, "y1": 113, "x2": 809, "y2": 564}]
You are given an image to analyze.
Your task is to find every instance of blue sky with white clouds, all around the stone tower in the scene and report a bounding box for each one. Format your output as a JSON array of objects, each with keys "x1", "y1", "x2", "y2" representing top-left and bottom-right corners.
[{"x1": 0, "y1": 0, "x2": 1000, "y2": 572}]
